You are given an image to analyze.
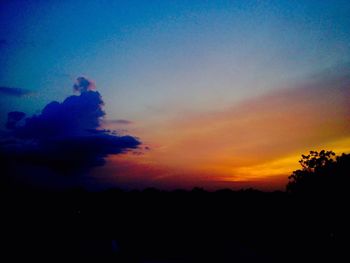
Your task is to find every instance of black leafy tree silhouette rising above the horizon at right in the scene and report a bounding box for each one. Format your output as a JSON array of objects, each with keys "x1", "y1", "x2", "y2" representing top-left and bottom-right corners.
[{"x1": 287, "y1": 150, "x2": 350, "y2": 194}]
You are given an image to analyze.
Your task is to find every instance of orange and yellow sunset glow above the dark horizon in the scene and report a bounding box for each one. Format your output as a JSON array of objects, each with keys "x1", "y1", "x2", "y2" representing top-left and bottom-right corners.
[{"x1": 102, "y1": 77, "x2": 350, "y2": 189}]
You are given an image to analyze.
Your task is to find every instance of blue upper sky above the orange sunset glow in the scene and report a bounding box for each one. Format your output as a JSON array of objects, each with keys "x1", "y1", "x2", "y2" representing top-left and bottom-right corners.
[{"x1": 0, "y1": 1, "x2": 350, "y2": 118}]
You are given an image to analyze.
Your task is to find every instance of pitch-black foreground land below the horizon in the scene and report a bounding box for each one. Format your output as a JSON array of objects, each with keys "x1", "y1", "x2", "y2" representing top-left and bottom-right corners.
[{"x1": 1, "y1": 189, "x2": 349, "y2": 263}]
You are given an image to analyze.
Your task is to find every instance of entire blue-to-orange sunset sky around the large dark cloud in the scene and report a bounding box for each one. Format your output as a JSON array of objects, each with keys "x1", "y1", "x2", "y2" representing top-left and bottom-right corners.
[{"x1": 0, "y1": 0, "x2": 350, "y2": 190}]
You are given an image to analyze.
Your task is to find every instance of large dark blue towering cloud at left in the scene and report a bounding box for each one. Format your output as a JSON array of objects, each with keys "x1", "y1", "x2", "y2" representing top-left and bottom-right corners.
[{"x1": 0, "y1": 77, "x2": 141, "y2": 177}]
